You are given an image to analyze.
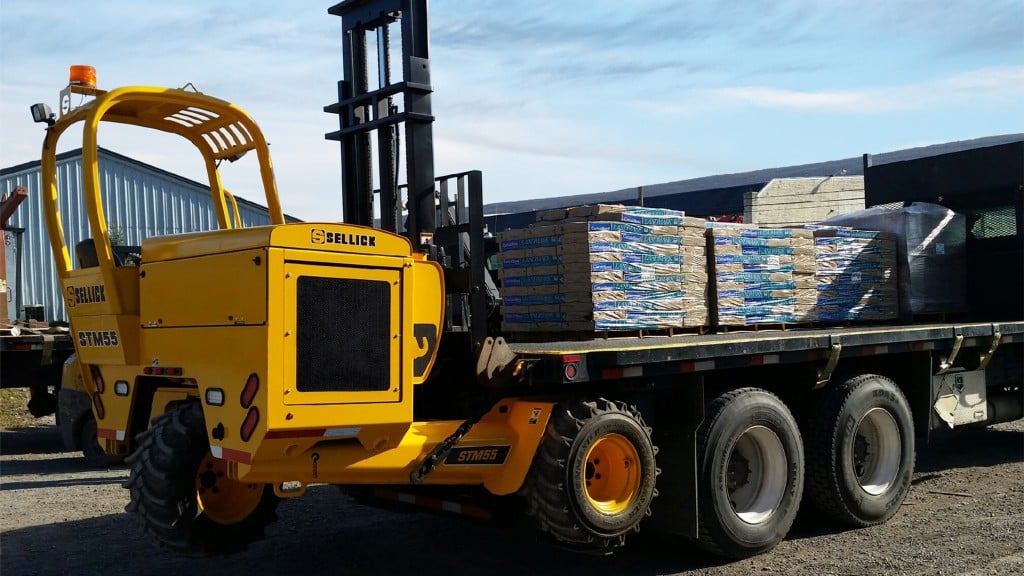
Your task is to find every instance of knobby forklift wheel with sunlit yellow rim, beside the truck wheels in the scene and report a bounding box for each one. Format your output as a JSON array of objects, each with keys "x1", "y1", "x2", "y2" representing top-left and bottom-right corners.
[{"x1": 521, "y1": 399, "x2": 657, "y2": 551}]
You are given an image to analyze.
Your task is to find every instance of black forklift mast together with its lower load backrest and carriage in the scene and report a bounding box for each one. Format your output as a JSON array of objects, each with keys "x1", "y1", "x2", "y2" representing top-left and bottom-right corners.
[{"x1": 324, "y1": 0, "x2": 491, "y2": 351}]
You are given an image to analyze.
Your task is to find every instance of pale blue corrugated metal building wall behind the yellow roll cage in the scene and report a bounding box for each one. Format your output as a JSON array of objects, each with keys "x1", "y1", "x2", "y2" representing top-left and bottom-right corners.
[{"x1": 0, "y1": 150, "x2": 280, "y2": 322}]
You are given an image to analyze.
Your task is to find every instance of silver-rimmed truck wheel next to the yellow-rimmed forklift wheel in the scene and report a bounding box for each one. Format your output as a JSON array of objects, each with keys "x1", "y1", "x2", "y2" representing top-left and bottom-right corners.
[{"x1": 696, "y1": 387, "x2": 804, "y2": 559}]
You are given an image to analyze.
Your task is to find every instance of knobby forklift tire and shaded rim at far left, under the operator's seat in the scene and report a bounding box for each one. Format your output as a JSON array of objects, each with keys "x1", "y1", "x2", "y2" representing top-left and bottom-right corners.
[{"x1": 125, "y1": 402, "x2": 279, "y2": 556}]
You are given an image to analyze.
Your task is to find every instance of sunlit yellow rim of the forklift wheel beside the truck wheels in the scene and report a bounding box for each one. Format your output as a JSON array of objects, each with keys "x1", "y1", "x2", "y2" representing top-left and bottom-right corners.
[{"x1": 583, "y1": 434, "x2": 641, "y2": 515}]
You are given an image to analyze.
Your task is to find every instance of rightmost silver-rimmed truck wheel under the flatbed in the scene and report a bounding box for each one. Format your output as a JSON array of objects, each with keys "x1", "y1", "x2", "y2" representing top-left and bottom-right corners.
[{"x1": 807, "y1": 374, "x2": 914, "y2": 527}]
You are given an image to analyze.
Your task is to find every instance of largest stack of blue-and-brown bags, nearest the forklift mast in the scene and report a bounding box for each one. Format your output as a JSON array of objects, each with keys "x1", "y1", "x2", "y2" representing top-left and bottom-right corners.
[{"x1": 499, "y1": 205, "x2": 708, "y2": 332}]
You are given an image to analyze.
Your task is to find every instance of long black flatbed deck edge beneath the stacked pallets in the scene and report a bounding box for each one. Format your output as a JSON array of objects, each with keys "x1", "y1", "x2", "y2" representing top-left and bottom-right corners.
[{"x1": 509, "y1": 322, "x2": 1024, "y2": 382}]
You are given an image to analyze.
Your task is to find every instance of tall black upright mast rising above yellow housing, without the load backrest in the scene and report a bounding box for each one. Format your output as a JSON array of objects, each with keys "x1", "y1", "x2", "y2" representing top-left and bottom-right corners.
[{"x1": 325, "y1": 0, "x2": 436, "y2": 239}]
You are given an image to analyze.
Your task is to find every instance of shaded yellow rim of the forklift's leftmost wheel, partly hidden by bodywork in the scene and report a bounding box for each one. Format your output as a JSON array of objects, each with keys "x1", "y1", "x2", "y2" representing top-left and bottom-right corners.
[{"x1": 196, "y1": 453, "x2": 263, "y2": 525}]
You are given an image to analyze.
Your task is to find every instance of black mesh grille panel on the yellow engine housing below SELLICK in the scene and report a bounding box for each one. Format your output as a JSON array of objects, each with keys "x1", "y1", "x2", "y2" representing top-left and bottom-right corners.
[{"x1": 295, "y1": 276, "x2": 391, "y2": 392}]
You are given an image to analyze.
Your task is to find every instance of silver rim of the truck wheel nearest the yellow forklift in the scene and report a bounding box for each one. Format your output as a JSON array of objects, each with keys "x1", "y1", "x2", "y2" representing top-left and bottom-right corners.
[{"x1": 726, "y1": 426, "x2": 788, "y2": 524}]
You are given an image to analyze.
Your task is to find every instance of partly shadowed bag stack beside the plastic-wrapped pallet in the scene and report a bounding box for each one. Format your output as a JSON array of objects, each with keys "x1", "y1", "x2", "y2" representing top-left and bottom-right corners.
[{"x1": 811, "y1": 227, "x2": 899, "y2": 322}]
